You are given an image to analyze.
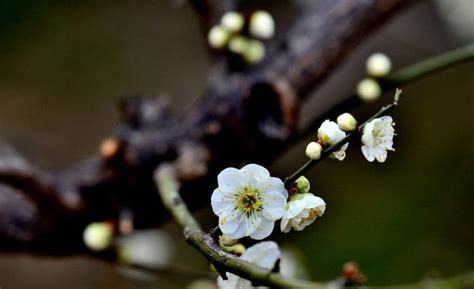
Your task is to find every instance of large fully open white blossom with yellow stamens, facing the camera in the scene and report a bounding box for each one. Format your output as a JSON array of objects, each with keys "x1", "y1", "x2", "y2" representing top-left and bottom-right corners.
[{"x1": 211, "y1": 164, "x2": 288, "y2": 240}]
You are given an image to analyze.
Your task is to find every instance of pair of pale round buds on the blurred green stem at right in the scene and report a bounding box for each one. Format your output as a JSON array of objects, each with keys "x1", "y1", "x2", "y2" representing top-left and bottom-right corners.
[{"x1": 356, "y1": 53, "x2": 392, "y2": 101}]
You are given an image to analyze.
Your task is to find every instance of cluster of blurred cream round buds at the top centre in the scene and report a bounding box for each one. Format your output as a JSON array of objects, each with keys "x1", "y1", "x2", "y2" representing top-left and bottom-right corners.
[{"x1": 207, "y1": 10, "x2": 275, "y2": 63}]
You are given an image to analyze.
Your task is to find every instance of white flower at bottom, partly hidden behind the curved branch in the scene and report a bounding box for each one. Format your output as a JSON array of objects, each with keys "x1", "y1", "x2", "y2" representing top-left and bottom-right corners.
[{"x1": 217, "y1": 241, "x2": 281, "y2": 289}]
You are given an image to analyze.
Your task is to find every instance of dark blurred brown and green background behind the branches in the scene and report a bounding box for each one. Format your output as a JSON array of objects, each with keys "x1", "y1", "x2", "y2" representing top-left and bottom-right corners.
[{"x1": 0, "y1": 0, "x2": 474, "y2": 289}]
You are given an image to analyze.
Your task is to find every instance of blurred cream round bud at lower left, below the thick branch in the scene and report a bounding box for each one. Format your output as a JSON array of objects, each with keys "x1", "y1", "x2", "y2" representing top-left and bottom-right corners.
[{"x1": 82, "y1": 222, "x2": 113, "y2": 251}]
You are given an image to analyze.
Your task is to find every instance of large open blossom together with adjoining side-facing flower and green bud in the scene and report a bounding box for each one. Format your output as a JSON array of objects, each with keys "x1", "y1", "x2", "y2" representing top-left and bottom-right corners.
[{"x1": 211, "y1": 164, "x2": 326, "y2": 240}]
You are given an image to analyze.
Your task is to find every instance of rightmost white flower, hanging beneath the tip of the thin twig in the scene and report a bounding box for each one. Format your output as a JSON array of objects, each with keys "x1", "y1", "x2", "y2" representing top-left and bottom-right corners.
[{"x1": 361, "y1": 116, "x2": 395, "y2": 163}]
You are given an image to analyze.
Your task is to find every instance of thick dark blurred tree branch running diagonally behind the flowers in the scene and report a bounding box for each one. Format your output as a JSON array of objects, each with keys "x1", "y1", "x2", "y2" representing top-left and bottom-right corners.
[{"x1": 0, "y1": 0, "x2": 422, "y2": 254}]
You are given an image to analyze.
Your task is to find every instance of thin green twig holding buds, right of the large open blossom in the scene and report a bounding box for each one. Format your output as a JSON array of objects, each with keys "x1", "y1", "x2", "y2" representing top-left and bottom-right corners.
[{"x1": 285, "y1": 89, "x2": 402, "y2": 188}]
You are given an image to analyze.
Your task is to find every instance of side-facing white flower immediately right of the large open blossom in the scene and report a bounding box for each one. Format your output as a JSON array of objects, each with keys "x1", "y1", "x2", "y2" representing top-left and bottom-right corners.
[{"x1": 280, "y1": 193, "x2": 326, "y2": 233}]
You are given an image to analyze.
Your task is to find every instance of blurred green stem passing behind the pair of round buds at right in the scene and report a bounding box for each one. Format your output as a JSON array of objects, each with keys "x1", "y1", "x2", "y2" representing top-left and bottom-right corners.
[{"x1": 295, "y1": 44, "x2": 474, "y2": 140}]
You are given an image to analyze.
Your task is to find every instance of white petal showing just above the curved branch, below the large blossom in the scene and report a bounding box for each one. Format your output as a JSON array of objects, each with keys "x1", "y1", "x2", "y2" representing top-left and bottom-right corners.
[{"x1": 240, "y1": 241, "x2": 281, "y2": 269}]
